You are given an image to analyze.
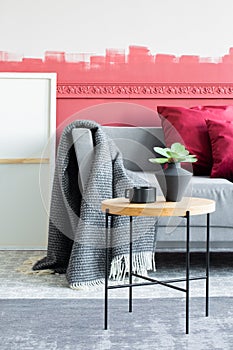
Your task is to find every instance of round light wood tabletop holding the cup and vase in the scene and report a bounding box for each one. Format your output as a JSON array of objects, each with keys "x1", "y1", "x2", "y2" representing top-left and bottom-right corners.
[{"x1": 101, "y1": 197, "x2": 215, "y2": 216}]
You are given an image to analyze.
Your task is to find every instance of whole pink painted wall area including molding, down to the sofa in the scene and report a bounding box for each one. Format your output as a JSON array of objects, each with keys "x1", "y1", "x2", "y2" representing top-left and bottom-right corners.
[{"x1": 0, "y1": 46, "x2": 233, "y2": 128}]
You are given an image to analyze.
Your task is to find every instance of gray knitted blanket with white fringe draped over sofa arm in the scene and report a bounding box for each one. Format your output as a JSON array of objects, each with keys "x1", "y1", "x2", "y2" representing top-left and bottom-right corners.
[{"x1": 33, "y1": 120, "x2": 157, "y2": 288}]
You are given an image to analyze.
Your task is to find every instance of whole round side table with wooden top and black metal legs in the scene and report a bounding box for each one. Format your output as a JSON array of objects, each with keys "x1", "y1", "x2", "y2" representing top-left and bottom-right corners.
[{"x1": 101, "y1": 197, "x2": 215, "y2": 334}]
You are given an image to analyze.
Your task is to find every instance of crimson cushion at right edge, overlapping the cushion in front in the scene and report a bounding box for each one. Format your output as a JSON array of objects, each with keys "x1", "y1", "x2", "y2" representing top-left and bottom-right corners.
[{"x1": 206, "y1": 120, "x2": 233, "y2": 182}]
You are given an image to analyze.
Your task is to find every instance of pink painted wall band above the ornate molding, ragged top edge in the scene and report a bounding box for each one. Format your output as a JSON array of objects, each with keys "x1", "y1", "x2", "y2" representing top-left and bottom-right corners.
[{"x1": 0, "y1": 46, "x2": 233, "y2": 83}]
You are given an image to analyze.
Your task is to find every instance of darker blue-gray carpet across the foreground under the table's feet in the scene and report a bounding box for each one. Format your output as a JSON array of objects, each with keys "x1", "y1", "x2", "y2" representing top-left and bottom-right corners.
[{"x1": 0, "y1": 297, "x2": 233, "y2": 350}]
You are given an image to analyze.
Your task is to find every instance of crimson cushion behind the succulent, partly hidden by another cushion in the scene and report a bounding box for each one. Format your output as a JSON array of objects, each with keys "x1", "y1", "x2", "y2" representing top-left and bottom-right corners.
[{"x1": 157, "y1": 106, "x2": 233, "y2": 175}]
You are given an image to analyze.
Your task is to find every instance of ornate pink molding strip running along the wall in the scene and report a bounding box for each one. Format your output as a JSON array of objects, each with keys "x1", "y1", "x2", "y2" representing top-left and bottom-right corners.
[{"x1": 57, "y1": 83, "x2": 233, "y2": 99}]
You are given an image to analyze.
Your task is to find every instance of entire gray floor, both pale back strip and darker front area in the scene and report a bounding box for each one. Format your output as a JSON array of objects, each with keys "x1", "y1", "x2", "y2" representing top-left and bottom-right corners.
[{"x1": 0, "y1": 251, "x2": 233, "y2": 350}]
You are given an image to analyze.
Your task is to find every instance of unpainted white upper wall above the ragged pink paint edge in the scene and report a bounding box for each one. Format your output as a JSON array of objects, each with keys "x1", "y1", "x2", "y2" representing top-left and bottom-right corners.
[{"x1": 0, "y1": 0, "x2": 233, "y2": 57}]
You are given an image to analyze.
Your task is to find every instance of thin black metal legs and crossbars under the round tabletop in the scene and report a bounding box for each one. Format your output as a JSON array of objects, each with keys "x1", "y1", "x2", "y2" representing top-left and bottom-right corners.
[{"x1": 104, "y1": 209, "x2": 210, "y2": 334}]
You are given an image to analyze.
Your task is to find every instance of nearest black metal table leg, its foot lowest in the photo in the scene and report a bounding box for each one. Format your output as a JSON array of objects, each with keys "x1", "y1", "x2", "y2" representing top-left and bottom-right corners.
[{"x1": 186, "y1": 211, "x2": 190, "y2": 334}]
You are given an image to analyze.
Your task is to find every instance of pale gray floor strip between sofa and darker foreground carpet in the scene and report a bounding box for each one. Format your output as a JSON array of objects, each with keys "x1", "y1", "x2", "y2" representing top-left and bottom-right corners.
[{"x1": 0, "y1": 251, "x2": 233, "y2": 299}]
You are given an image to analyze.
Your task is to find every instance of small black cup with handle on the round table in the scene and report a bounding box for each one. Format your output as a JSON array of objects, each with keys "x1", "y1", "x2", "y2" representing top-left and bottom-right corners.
[{"x1": 125, "y1": 186, "x2": 156, "y2": 203}]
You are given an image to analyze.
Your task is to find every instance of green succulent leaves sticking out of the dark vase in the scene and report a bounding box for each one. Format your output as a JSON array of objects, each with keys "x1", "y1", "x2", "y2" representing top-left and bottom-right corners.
[{"x1": 149, "y1": 142, "x2": 197, "y2": 164}]
